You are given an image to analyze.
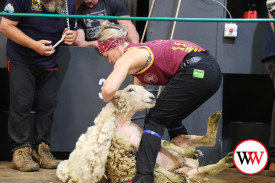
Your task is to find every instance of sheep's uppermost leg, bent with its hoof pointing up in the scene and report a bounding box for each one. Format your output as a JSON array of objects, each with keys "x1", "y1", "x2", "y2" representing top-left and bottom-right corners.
[{"x1": 171, "y1": 111, "x2": 222, "y2": 149}]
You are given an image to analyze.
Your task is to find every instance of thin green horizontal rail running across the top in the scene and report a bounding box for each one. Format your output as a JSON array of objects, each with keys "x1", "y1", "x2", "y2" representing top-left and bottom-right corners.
[{"x1": 0, "y1": 12, "x2": 275, "y2": 23}]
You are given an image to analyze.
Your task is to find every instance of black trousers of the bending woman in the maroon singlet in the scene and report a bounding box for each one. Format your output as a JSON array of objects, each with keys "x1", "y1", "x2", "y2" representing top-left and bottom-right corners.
[{"x1": 137, "y1": 51, "x2": 222, "y2": 179}]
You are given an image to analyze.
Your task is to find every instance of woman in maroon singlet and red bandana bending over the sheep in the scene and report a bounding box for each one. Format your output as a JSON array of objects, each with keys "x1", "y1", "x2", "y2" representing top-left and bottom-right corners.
[{"x1": 98, "y1": 22, "x2": 222, "y2": 183}]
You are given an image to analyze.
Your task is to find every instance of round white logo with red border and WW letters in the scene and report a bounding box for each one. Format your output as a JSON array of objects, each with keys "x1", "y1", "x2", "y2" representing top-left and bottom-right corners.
[{"x1": 233, "y1": 139, "x2": 268, "y2": 175}]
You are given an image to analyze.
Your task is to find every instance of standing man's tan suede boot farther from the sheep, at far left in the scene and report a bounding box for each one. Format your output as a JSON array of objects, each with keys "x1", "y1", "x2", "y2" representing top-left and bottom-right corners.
[{"x1": 12, "y1": 147, "x2": 40, "y2": 172}]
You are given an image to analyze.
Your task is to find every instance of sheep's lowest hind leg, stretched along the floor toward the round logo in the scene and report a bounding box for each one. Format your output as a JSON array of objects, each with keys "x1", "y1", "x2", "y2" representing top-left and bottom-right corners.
[{"x1": 175, "y1": 152, "x2": 234, "y2": 177}]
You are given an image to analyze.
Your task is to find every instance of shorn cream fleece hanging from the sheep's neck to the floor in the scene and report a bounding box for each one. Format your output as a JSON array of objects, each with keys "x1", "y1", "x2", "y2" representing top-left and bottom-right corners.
[{"x1": 56, "y1": 103, "x2": 116, "y2": 183}]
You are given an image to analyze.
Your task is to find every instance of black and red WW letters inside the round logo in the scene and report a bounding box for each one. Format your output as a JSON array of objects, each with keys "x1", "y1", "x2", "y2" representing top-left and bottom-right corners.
[{"x1": 236, "y1": 151, "x2": 264, "y2": 165}]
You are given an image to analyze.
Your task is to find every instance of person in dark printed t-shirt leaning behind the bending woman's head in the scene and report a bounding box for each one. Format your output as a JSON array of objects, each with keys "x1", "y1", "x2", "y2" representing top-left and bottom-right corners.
[{"x1": 75, "y1": 0, "x2": 139, "y2": 47}]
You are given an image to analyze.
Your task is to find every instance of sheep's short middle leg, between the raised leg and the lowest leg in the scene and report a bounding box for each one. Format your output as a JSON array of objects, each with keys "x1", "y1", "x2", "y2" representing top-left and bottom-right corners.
[{"x1": 161, "y1": 140, "x2": 203, "y2": 159}]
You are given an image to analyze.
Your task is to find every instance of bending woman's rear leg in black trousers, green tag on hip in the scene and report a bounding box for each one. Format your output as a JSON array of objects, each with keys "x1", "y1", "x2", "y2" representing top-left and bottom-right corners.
[{"x1": 156, "y1": 51, "x2": 222, "y2": 139}]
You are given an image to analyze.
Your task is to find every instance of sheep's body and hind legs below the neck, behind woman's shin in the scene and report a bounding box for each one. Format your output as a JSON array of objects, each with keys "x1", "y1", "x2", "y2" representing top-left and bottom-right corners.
[{"x1": 102, "y1": 111, "x2": 234, "y2": 183}]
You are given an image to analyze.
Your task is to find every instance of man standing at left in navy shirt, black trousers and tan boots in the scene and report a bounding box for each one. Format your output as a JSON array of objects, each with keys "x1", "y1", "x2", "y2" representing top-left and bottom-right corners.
[{"x1": 0, "y1": 0, "x2": 77, "y2": 171}]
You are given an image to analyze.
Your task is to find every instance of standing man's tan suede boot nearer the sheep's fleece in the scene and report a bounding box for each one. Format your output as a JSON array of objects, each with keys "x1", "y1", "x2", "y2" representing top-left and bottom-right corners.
[{"x1": 32, "y1": 142, "x2": 60, "y2": 169}]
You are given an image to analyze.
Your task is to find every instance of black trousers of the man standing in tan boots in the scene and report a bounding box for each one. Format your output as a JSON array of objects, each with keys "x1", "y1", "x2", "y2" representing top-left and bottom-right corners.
[{"x1": 8, "y1": 64, "x2": 58, "y2": 151}]
